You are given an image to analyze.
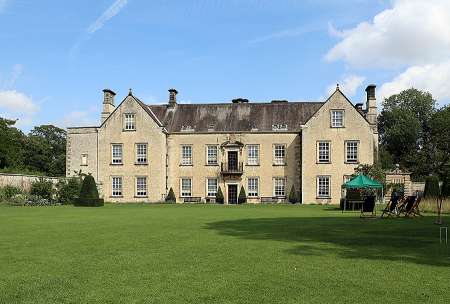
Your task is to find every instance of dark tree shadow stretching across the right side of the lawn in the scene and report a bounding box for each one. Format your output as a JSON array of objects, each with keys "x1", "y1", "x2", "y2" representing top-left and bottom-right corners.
[{"x1": 206, "y1": 217, "x2": 450, "y2": 267}]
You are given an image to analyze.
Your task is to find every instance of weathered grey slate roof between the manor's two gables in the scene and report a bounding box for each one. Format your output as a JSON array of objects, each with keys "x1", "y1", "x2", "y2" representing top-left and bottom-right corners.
[{"x1": 147, "y1": 102, "x2": 324, "y2": 133}]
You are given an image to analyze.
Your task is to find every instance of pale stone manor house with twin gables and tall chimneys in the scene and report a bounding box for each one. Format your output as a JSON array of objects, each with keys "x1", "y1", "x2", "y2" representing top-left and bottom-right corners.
[{"x1": 66, "y1": 85, "x2": 378, "y2": 204}]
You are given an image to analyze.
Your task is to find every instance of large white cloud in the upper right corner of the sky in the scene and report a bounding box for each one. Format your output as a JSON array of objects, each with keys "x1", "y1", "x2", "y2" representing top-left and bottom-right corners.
[{"x1": 325, "y1": 0, "x2": 450, "y2": 68}]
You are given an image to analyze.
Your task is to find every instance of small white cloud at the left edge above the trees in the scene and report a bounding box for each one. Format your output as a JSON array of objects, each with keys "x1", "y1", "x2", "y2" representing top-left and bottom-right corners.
[{"x1": 0, "y1": 90, "x2": 39, "y2": 126}]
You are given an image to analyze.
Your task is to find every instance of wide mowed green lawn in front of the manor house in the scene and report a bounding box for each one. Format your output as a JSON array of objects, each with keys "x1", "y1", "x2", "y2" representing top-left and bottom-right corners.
[{"x1": 0, "y1": 205, "x2": 450, "y2": 304}]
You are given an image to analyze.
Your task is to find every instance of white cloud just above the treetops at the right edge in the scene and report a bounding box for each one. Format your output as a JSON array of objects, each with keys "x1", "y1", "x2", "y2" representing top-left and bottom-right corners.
[{"x1": 379, "y1": 60, "x2": 450, "y2": 101}]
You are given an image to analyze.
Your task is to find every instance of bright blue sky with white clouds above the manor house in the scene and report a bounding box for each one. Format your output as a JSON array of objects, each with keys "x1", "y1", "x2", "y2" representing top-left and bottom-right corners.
[{"x1": 0, "y1": 0, "x2": 450, "y2": 131}]
